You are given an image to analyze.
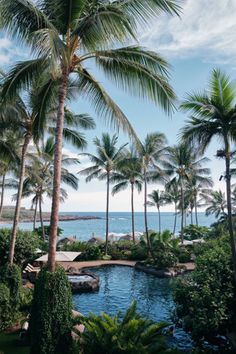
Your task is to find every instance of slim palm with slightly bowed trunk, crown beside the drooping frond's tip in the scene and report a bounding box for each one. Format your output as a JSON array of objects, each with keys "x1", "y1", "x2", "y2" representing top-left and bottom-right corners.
[{"x1": 139, "y1": 133, "x2": 167, "y2": 253}]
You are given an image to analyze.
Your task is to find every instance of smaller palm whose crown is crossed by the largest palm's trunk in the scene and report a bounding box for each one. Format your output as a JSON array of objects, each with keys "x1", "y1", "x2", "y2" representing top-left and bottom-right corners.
[{"x1": 22, "y1": 137, "x2": 79, "y2": 239}]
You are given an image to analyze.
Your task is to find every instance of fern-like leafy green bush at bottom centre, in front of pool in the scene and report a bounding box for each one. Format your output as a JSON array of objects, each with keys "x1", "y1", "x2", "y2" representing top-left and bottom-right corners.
[{"x1": 75, "y1": 302, "x2": 180, "y2": 354}]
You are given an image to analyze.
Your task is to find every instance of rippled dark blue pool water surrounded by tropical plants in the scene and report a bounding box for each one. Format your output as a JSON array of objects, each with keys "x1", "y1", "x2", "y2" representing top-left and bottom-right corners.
[{"x1": 73, "y1": 266, "x2": 192, "y2": 351}]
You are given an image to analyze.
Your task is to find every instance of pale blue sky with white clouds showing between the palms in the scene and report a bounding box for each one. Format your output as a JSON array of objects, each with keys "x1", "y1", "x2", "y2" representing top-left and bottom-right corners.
[{"x1": 0, "y1": 0, "x2": 236, "y2": 213}]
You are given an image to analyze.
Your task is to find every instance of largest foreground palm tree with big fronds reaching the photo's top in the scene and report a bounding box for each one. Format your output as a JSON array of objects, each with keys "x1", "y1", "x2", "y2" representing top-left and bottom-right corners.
[{"x1": 0, "y1": 0, "x2": 180, "y2": 271}]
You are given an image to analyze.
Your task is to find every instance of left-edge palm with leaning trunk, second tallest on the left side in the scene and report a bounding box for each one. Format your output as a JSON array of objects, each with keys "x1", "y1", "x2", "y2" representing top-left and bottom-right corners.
[{"x1": 0, "y1": 81, "x2": 94, "y2": 264}]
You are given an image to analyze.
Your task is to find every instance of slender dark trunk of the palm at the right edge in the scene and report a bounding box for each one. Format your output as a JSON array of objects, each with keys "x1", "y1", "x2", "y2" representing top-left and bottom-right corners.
[{"x1": 225, "y1": 149, "x2": 236, "y2": 282}]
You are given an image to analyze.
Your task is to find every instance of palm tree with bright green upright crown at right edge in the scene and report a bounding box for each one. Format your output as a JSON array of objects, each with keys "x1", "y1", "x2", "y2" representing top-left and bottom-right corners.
[{"x1": 181, "y1": 69, "x2": 236, "y2": 281}]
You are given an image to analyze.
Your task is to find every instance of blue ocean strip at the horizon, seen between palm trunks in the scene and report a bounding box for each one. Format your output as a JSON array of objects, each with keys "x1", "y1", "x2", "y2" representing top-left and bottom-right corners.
[{"x1": 0, "y1": 212, "x2": 216, "y2": 240}]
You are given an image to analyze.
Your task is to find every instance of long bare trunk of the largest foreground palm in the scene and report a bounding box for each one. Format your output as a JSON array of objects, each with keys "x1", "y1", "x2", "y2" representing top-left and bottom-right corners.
[{"x1": 48, "y1": 68, "x2": 69, "y2": 272}]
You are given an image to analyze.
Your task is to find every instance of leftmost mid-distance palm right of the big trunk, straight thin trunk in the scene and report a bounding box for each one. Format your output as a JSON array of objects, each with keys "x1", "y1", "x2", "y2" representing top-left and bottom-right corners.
[{"x1": 79, "y1": 133, "x2": 127, "y2": 254}]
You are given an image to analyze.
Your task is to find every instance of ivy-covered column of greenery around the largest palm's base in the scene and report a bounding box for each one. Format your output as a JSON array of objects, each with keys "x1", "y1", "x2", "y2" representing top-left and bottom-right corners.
[{"x1": 30, "y1": 267, "x2": 72, "y2": 354}]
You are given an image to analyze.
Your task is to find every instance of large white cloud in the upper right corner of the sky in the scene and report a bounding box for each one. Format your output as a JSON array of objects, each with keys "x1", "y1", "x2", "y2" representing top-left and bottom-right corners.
[{"x1": 140, "y1": 0, "x2": 236, "y2": 63}]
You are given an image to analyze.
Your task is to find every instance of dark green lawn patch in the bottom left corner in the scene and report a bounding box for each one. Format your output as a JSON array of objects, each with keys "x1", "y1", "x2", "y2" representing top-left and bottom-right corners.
[{"x1": 0, "y1": 333, "x2": 29, "y2": 354}]
